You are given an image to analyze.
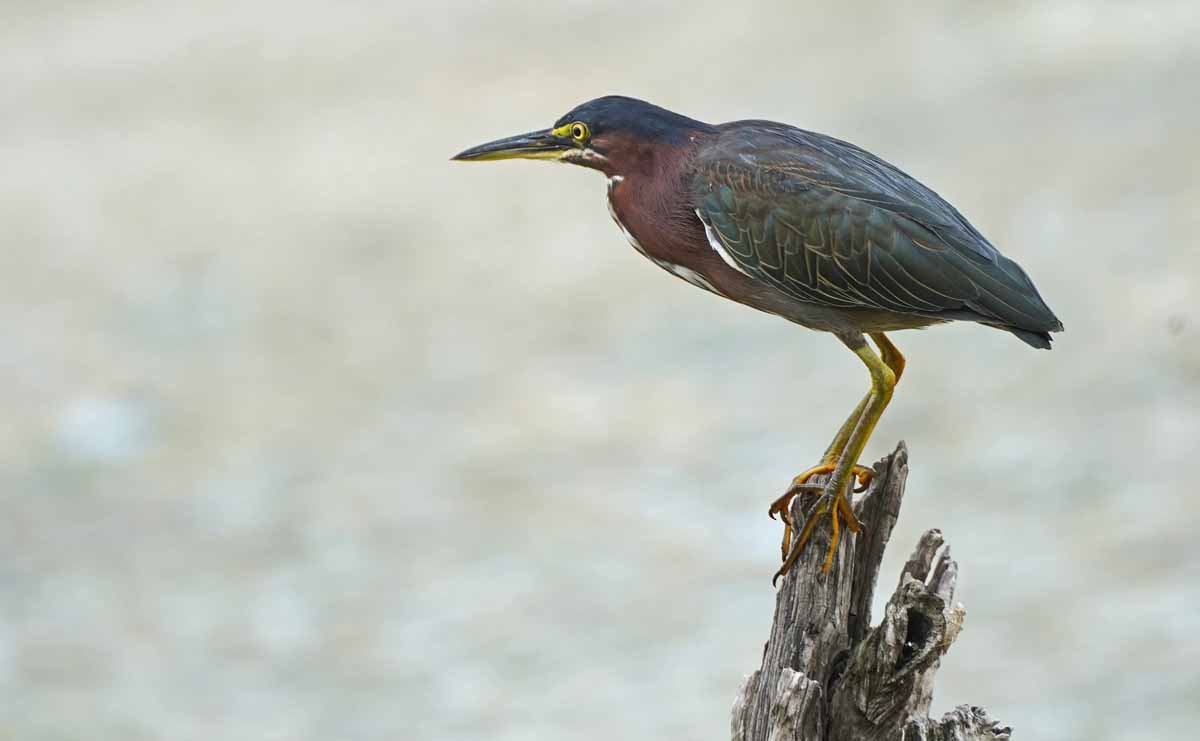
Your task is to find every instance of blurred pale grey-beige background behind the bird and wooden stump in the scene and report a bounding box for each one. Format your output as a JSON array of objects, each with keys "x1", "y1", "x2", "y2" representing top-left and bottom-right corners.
[{"x1": 0, "y1": 0, "x2": 1200, "y2": 741}]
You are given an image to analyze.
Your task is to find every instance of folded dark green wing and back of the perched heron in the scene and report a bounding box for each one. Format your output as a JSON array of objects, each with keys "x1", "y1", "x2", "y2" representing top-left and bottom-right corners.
[{"x1": 692, "y1": 121, "x2": 1061, "y2": 332}]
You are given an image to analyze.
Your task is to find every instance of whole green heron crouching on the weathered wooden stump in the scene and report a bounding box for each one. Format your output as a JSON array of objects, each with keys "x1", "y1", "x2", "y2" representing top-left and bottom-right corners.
[{"x1": 454, "y1": 96, "x2": 1062, "y2": 578}]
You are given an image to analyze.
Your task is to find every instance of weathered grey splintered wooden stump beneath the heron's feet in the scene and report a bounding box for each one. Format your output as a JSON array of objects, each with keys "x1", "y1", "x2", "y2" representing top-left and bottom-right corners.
[{"x1": 731, "y1": 442, "x2": 1010, "y2": 741}]
